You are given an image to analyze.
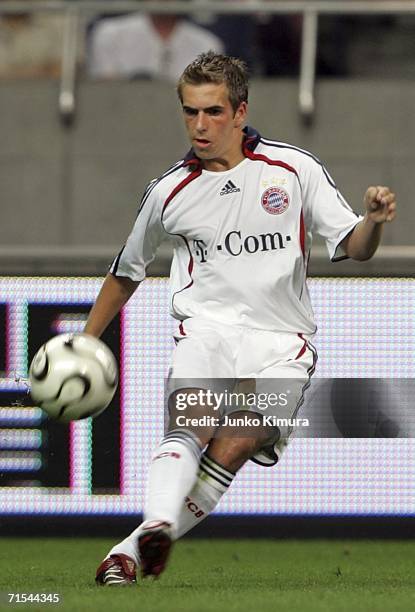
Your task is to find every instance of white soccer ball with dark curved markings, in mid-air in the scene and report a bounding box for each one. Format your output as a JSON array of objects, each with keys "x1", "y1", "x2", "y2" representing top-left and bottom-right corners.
[{"x1": 29, "y1": 334, "x2": 118, "y2": 423}]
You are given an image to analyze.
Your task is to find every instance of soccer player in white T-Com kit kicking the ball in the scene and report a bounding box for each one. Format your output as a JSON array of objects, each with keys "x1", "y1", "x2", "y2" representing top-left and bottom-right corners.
[{"x1": 85, "y1": 52, "x2": 396, "y2": 585}]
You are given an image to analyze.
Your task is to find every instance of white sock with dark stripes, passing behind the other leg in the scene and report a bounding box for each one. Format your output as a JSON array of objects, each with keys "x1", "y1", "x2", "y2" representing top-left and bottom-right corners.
[{"x1": 108, "y1": 455, "x2": 235, "y2": 565}]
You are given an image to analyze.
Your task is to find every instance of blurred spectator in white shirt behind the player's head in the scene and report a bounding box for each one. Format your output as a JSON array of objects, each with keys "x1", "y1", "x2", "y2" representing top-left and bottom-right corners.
[{"x1": 88, "y1": 5, "x2": 224, "y2": 81}]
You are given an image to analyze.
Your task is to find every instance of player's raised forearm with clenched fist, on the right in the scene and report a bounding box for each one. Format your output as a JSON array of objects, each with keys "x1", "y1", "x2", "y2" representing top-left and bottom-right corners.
[{"x1": 342, "y1": 186, "x2": 396, "y2": 261}]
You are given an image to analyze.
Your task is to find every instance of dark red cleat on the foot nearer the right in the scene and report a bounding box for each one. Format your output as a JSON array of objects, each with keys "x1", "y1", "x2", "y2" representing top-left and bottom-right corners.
[{"x1": 138, "y1": 521, "x2": 173, "y2": 578}]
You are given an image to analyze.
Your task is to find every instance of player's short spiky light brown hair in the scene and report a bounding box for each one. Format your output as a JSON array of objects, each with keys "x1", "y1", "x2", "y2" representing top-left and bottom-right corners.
[{"x1": 177, "y1": 51, "x2": 249, "y2": 112}]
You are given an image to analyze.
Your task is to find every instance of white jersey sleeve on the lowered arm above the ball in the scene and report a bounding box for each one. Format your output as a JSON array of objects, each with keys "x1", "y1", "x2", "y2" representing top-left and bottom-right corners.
[{"x1": 109, "y1": 183, "x2": 166, "y2": 281}]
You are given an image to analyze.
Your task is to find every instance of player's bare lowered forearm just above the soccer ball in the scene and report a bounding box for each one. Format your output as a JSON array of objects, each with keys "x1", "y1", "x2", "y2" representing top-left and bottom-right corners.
[{"x1": 84, "y1": 273, "x2": 140, "y2": 338}]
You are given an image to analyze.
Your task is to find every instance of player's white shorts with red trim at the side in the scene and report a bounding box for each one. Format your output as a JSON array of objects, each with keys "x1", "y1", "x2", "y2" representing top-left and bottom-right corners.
[{"x1": 166, "y1": 318, "x2": 317, "y2": 442}]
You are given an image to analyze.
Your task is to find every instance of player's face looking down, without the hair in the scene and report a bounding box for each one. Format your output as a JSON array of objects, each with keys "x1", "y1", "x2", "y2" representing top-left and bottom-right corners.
[{"x1": 182, "y1": 83, "x2": 247, "y2": 171}]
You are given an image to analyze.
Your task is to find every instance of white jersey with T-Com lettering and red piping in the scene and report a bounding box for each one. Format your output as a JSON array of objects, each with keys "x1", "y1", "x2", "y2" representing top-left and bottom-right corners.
[{"x1": 110, "y1": 128, "x2": 362, "y2": 334}]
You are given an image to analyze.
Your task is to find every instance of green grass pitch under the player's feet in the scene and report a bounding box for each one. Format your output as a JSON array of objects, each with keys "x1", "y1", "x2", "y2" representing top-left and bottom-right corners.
[{"x1": 0, "y1": 538, "x2": 415, "y2": 612}]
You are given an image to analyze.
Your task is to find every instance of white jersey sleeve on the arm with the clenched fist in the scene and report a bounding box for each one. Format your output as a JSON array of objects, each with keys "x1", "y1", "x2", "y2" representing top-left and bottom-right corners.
[{"x1": 304, "y1": 160, "x2": 363, "y2": 261}]
